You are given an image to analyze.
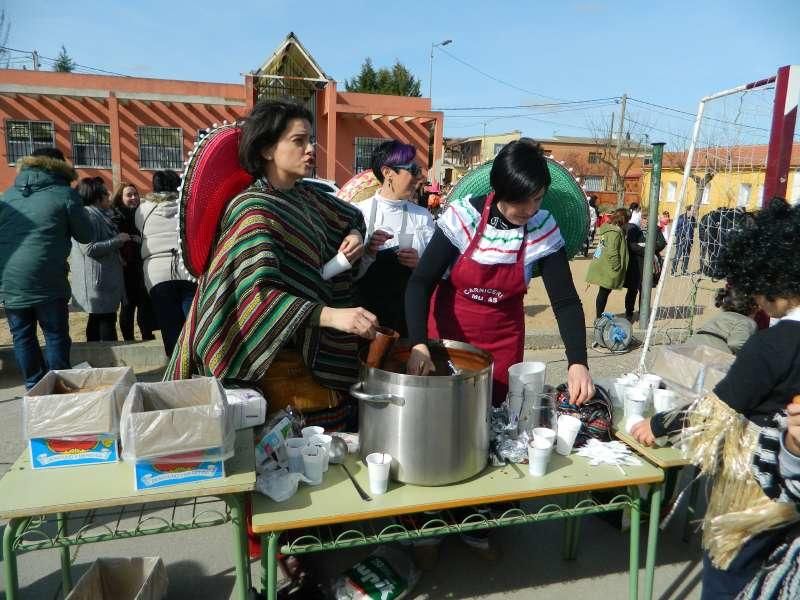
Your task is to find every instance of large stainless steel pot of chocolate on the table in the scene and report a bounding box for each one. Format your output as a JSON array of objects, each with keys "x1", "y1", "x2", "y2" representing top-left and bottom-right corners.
[{"x1": 351, "y1": 340, "x2": 492, "y2": 486}]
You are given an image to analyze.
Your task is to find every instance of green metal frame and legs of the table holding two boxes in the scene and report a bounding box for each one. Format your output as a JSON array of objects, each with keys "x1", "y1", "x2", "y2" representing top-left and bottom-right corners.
[{"x1": 3, "y1": 494, "x2": 252, "y2": 600}]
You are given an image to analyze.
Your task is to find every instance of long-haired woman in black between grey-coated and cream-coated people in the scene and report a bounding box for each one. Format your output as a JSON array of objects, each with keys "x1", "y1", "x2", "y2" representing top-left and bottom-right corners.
[{"x1": 111, "y1": 181, "x2": 156, "y2": 342}]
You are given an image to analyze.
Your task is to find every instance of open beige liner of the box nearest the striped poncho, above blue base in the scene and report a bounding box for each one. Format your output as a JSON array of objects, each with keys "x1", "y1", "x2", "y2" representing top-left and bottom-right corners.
[{"x1": 120, "y1": 377, "x2": 236, "y2": 463}]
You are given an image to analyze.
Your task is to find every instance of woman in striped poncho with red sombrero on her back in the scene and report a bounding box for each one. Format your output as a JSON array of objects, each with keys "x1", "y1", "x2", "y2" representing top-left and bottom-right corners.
[{"x1": 166, "y1": 101, "x2": 377, "y2": 430}]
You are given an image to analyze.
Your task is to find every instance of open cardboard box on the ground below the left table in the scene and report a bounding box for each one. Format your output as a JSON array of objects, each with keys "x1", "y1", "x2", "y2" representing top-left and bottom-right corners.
[{"x1": 64, "y1": 557, "x2": 169, "y2": 600}]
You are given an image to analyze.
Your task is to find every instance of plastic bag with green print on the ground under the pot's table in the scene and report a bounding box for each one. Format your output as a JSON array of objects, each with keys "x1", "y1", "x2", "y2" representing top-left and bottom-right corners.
[{"x1": 333, "y1": 546, "x2": 420, "y2": 600}]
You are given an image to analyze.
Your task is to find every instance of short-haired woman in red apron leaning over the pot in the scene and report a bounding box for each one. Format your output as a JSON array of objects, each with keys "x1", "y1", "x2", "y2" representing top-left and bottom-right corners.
[{"x1": 406, "y1": 138, "x2": 594, "y2": 406}]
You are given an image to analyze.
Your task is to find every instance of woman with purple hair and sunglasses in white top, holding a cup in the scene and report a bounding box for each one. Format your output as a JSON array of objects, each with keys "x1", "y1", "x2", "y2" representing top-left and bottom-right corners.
[{"x1": 356, "y1": 140, "x2": 434, "y2": 337}]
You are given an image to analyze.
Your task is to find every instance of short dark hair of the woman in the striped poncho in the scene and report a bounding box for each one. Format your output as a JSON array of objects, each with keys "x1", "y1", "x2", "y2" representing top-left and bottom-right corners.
[{"x1": 239, "y1": 100, "x2": 314, "y2": 177}]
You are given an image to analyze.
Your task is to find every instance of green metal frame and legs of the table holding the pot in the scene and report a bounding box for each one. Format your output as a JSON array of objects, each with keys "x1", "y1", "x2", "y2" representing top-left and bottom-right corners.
[{"x1": 261, "y1": 484, "x2": 662, "y2": 600}]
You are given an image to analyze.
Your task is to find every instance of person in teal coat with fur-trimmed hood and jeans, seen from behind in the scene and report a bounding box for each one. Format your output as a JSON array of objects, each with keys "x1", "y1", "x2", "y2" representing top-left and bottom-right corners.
[{"x1": 0, "y1": 148, "x2": 92, "y2": 389}]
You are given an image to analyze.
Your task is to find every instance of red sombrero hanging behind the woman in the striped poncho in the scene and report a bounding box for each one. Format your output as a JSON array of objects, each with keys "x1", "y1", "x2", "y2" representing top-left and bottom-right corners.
[{"x1": 178, "y1": 123, "x2": 253, "y2": 277}]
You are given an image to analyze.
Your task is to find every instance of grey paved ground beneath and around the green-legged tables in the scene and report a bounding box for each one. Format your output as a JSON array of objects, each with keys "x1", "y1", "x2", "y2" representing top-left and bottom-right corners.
[{"x1": 0, "y1": 350, "x2": 700, "y2": 600}]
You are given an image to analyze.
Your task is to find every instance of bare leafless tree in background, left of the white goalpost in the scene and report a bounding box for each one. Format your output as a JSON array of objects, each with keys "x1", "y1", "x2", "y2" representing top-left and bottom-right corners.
[{"x1": 588, "y1": 115, "x2": 652, "y2": 207}]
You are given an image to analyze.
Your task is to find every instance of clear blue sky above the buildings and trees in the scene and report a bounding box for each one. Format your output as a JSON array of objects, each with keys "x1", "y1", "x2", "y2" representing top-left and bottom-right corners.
[{"x1": 0, "y1": 0, "x2": 800, "y2": 141}]
